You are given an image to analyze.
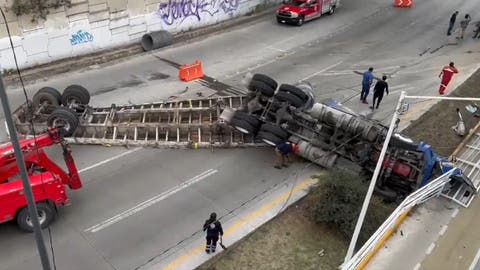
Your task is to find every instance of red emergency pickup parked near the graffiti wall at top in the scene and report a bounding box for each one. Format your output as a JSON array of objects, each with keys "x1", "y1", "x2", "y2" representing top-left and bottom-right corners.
[{"x1": 277, "y1": 0, "x2": 340, "y2": 26}]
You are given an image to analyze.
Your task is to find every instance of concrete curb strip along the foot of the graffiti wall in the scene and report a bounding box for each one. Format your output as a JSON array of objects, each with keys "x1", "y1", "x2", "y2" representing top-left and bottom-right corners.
[{"x1": 3, "y1": 3, "x2": 276, "y2": 86}]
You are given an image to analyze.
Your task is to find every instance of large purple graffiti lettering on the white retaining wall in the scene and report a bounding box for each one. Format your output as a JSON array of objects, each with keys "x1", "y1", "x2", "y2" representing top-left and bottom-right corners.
[{"x1": 157, "y1": 0, "x2": 240, "y2": 25}]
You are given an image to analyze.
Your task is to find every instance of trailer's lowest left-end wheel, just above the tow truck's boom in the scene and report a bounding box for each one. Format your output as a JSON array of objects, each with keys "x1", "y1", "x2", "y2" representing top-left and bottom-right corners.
[{"x1": 47, "y1": 107, "x2": 79, "y2": 137}]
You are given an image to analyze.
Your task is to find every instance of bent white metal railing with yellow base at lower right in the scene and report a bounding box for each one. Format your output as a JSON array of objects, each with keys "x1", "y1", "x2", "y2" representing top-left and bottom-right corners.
[{"x1": 341, "y1": 168, "x2": 456, "y2": 270}]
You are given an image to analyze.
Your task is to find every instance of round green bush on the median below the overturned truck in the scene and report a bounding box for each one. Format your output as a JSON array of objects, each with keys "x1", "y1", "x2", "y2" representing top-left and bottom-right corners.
[{"x1": 310, "y1": 169, "x2": 395, "y2": 245}]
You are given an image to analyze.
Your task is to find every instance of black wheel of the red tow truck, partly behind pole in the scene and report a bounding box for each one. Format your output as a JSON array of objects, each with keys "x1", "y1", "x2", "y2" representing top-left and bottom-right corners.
[{"x1": 17, "y1": 202, "x2": 55, "y2": 232}]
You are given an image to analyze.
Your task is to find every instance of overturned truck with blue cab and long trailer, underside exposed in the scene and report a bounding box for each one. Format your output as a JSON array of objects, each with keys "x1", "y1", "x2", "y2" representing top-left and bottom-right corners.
[{"x1": 14, "y1": 74, "x2": 476, "y2": 200}]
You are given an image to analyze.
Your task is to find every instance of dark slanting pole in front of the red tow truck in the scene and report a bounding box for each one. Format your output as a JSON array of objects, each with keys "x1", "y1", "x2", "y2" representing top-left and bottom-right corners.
[{"x1": 0, "y1": 75, "x2": 51, "y2": 270}]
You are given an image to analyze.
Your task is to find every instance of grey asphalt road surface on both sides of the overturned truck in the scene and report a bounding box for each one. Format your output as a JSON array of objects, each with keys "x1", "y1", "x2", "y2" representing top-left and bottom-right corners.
[{"x1": 0, "y1": 0, "x2": 480, "y2": 269}]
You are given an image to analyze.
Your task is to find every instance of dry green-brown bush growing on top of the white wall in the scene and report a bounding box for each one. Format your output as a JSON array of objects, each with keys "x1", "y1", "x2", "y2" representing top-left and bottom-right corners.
[{"x1": 12, "y1": 0, "x2": 71, "y2": 21}]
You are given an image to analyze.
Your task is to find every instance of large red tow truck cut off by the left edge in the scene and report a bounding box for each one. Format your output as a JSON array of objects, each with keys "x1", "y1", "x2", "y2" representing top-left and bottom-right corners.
[{"x1": 0, "y1": 125, "x2": 82, "y2": 232}]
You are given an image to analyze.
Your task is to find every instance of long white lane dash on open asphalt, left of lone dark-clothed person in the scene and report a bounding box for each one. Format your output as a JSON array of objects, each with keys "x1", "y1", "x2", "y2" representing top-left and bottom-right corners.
[{"x1": 85, "y1": 169, "x2": 218, "y2": 233}]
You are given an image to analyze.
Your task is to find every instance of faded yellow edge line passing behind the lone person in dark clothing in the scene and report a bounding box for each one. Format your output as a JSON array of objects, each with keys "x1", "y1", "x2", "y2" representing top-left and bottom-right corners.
[{"x1": 161, "y1": 178, "x2": 316, "y2": 270}]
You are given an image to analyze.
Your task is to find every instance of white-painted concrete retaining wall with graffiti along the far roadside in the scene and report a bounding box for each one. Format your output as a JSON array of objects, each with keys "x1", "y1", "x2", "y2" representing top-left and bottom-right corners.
[{"x1": 0, "y1": 0, "x2": 280, "y2": 71}]
